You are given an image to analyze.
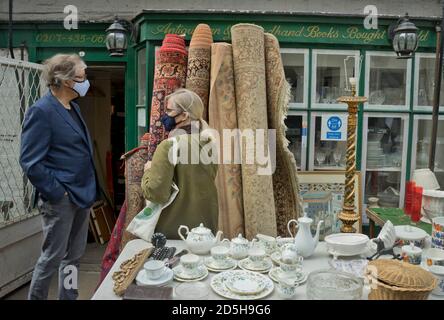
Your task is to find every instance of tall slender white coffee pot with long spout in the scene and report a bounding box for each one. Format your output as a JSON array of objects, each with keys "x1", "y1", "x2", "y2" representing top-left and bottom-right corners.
[{"x1": 287, "y1": 212, "x2": 324, "y2": 258}]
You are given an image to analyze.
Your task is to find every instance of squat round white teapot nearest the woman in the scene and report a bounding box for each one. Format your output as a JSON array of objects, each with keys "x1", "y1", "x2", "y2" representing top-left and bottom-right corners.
[{"x1": 177, "y1": 223, "x2": 222, "y2": 254}]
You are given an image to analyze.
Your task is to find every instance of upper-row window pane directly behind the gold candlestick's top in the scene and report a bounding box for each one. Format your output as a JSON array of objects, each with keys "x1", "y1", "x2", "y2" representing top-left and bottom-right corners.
[{"x1": 314, "y1": 54, "x2": 355, "y2": 103}]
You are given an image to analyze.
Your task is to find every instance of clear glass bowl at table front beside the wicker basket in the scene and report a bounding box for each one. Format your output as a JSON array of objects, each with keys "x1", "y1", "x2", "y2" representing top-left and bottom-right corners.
[{"x1": 307, "y1": 270, "x2": 364, "y2": 300}]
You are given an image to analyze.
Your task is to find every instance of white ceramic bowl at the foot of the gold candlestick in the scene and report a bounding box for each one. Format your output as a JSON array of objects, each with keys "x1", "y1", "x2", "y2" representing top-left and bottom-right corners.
[{"x1": 324, "y1": 233, "x2": 369, "y2": 256}]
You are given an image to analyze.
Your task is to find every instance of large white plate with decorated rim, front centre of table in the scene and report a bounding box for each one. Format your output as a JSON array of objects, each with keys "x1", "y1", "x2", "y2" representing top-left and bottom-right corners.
[{"x1": 210, "y1": 270, "x2": 274, "y2": 300}]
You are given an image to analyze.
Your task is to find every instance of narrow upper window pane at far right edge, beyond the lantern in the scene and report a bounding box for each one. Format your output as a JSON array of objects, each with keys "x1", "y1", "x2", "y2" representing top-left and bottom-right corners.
[{"x1": 416, "y1": 58, "x2": 444, "y2": 106}]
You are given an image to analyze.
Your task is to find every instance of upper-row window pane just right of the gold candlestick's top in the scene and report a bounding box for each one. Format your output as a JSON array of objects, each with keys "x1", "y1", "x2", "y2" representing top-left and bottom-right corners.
[{"x1": 369, "y1": 56, "x2": 407, "y2": 106}]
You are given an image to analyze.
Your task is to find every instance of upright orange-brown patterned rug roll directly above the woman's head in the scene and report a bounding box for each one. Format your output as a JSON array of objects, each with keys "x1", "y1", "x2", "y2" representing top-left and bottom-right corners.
[{"x1": 185, "y1": 24, "x2": 213, "y2": 121}]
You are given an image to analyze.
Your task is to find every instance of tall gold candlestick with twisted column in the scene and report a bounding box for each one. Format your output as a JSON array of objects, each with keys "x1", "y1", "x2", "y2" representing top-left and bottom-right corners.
[{"x1": 337, "y1": 78, "x2": 367, "y2": 233}]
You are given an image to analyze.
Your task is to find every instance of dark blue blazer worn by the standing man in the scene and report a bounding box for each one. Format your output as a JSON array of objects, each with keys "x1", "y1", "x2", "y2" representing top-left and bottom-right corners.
[{"x1": 20, "y1": 91, "x2": 98, "y2": 208}]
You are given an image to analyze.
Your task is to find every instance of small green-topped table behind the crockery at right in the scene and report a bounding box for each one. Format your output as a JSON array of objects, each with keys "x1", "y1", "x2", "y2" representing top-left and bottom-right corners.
[{"x1": 366, "y1": 208, "x2": 432, "y2": 238}]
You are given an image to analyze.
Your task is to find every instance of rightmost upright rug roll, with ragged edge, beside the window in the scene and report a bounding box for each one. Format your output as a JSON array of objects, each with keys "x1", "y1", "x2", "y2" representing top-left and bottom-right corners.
[{"x1": 265, "y1": 33, "x2": 300, "y2": 237}]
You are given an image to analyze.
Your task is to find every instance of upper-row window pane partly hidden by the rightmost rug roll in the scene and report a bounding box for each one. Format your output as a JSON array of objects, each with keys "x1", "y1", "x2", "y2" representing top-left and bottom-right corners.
[{"x1": 282, "y1": 53, "x2": 305, "y2": 103}]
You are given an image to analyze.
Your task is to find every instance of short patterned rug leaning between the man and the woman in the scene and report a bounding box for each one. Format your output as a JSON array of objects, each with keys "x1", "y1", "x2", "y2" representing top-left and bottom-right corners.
[{"x1": 120, "y1": 133, "x2": 150, "y2": 249}]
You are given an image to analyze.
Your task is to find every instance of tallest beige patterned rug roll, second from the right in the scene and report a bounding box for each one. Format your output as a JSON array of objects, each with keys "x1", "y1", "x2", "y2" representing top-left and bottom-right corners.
[{"x1": 231, "y1": 24, "x2": 276, "y2": 239}]
